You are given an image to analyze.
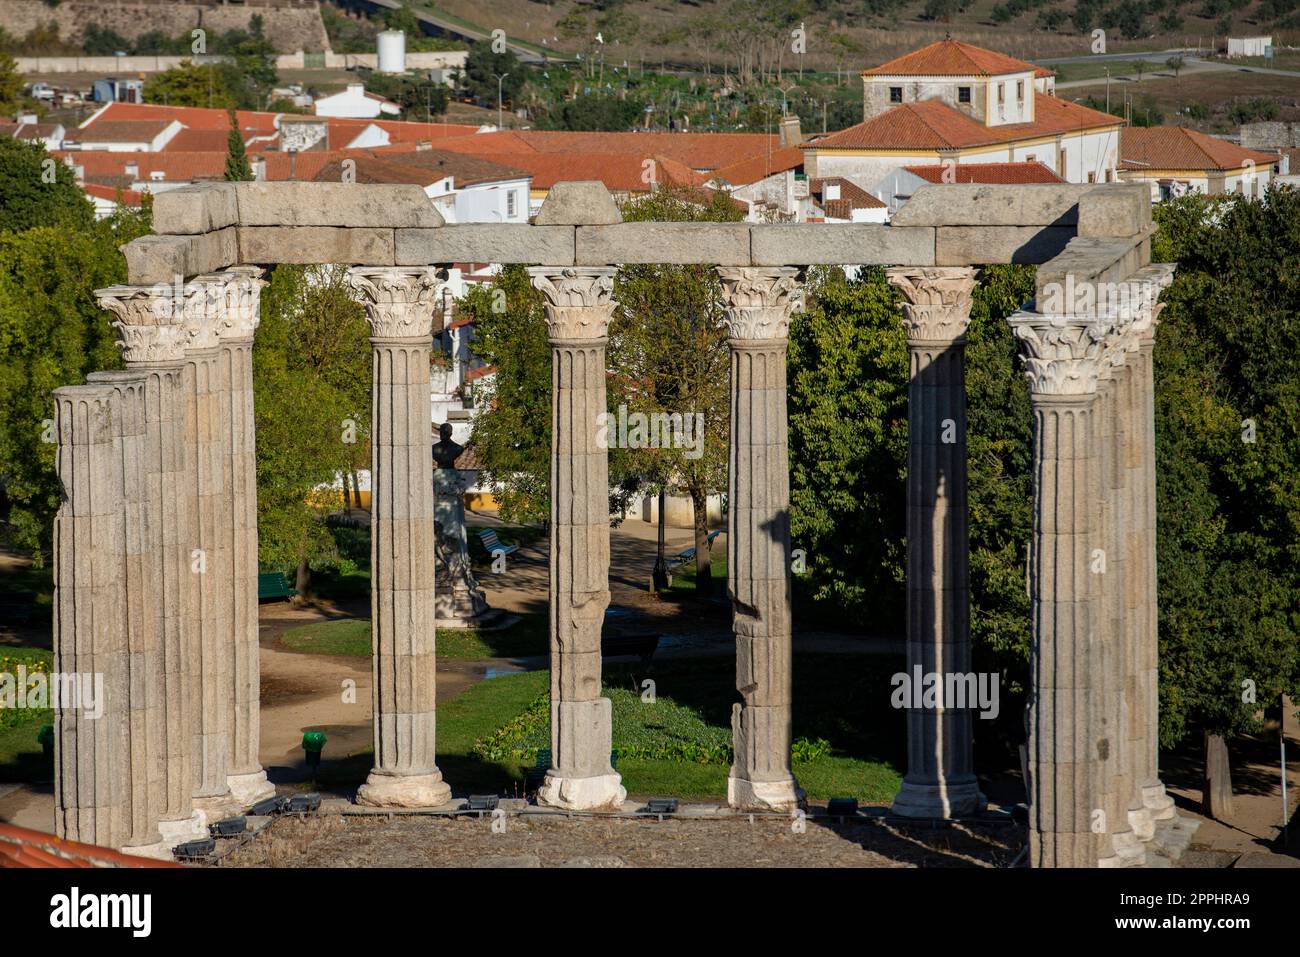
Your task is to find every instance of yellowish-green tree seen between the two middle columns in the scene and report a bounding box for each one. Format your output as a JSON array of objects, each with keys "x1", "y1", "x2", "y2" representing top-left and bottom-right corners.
[{"x1": 610, "y1": 186, "x2": 744, "y2": 594}]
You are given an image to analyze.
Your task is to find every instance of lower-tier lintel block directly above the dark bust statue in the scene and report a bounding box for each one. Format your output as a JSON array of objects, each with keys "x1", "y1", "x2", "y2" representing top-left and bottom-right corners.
[{"x1": 394, "y1": 223, "x2": 573, "y2": 265}]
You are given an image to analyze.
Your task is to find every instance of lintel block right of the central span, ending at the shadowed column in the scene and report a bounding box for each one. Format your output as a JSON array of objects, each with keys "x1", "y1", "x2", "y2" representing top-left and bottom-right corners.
[{"x1": 749, "y1": 222, "x2": 935, "y2": 265}]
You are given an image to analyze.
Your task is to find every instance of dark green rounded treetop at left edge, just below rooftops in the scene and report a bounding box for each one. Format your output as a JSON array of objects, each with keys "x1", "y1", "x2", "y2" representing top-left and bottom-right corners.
[{"x1": 0, "y1": 138, "x2": 95, "y2": 233}]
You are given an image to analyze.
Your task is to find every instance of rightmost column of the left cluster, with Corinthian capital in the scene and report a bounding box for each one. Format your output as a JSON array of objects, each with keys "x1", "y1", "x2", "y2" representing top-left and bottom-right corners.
[{"x1": 217, "y1": 267, "x2": 276, "y2": 807}]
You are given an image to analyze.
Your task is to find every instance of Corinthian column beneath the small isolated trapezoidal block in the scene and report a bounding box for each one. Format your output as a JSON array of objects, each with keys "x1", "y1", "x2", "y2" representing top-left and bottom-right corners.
[{"x1": 528, "y1": 267, "x2": 627, "y2": 810}]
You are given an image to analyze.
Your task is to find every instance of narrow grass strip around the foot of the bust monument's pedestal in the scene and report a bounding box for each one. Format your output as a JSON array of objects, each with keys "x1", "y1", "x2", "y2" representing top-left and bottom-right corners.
[{"x1": 280, "y1": 615, "x2": 550, "y2": 661}]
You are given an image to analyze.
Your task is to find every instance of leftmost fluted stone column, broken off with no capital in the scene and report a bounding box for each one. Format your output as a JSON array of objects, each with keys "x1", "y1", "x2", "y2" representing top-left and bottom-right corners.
[{"x1": 53, "y1": 382, "x2": 131, "y2": 848}]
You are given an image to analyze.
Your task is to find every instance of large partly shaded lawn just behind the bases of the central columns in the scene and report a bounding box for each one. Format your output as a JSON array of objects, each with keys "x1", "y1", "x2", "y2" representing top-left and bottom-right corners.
[{"x1": 321, "y1": 654, "x2": 906, "y2": 804}]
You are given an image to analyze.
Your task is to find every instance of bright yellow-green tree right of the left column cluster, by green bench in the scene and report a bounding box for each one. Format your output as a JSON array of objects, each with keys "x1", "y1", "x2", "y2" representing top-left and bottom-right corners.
[{"x1": 252, "y1": 265, "x2": 371, "y2": 592}]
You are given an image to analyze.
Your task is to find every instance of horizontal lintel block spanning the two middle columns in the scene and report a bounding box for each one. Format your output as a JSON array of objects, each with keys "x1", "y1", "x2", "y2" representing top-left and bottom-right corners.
[{"x1": 573, "y1": 222, "x2": 750, "y2": 265}]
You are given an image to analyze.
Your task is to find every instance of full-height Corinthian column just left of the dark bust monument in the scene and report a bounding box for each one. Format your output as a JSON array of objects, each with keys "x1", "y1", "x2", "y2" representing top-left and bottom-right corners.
[{"x1": 348, "y1": 267, "x2": 451, "y2": 807}]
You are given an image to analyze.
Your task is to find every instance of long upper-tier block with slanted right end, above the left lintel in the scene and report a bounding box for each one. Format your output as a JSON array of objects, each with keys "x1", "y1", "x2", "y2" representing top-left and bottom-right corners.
[{"x1": 235, "y1": 181, "x2": 442, "y2": 228}]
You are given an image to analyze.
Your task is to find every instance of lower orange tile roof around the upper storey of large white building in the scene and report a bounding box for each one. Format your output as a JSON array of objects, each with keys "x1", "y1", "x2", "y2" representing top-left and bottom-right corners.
[{"x1": 800, "y1": 95, "x2": 1123, "y2": 150}]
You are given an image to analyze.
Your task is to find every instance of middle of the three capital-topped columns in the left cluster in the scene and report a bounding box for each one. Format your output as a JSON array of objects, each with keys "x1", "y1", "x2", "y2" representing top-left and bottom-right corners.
[{"x1": 183, "y1": 276, "x2": 243, "y2": 823}]
